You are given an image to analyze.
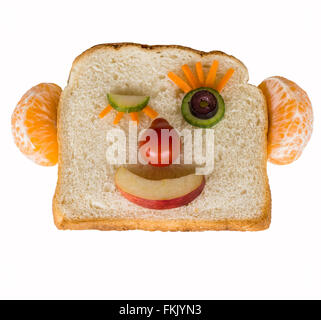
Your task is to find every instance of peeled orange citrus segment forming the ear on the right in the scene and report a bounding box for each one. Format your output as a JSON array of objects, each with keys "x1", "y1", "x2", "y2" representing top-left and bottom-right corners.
[{"x1": 259, "y1": 77, "x2": 313, "y2": 164}]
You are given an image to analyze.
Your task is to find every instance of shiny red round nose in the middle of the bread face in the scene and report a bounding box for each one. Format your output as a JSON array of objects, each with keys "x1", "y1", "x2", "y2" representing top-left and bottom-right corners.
[{"x1": 139, "y1": 118, "x2": 180, "y2": 167}]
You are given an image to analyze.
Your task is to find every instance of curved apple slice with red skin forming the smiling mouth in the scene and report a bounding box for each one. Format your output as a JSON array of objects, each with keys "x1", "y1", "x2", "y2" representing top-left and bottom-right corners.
[{"x1": 115, "y1": 167, "x2": 205, "y2": 210}]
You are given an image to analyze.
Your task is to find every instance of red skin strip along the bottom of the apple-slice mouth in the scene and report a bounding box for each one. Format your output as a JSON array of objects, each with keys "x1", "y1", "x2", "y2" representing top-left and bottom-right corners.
[{"x1": 116, "y1": 177, "x2": 205, "y2": 210}]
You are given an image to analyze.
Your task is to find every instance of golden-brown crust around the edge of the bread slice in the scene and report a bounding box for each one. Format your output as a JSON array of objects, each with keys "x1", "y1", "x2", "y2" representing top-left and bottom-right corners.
[{"x1": 53, "y1": 42, "x2": 271, "y2": 231}]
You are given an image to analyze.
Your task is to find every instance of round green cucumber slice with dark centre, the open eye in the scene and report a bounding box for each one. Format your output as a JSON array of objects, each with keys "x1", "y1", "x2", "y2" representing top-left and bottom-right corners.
[{"x1": 181, "y1": 87, "x2": 225, "y2": 128}]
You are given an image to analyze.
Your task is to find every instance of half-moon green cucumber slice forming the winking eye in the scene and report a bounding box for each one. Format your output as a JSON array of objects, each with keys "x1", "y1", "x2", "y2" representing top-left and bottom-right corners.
[{"x1": 107, "y1": 93, "x2": 149, "y2": 113}]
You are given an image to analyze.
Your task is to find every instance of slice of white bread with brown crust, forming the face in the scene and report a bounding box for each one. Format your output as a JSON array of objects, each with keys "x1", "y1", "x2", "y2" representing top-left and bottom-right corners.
[{"x1": 53, "y1": 43, "x2": 271, "y2": 231}]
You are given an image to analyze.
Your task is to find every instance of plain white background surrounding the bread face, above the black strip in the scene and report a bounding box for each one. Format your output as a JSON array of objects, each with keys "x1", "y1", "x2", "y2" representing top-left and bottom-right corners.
[{"x1": 0, "y1": 0, "x2": 321, "y2": 299}]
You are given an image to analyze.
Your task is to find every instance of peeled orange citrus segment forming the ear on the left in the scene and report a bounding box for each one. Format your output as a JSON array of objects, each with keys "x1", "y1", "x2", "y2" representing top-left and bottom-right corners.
[{"x1": 11, "y1": 83, "x2": 61, "y2": 166}]
